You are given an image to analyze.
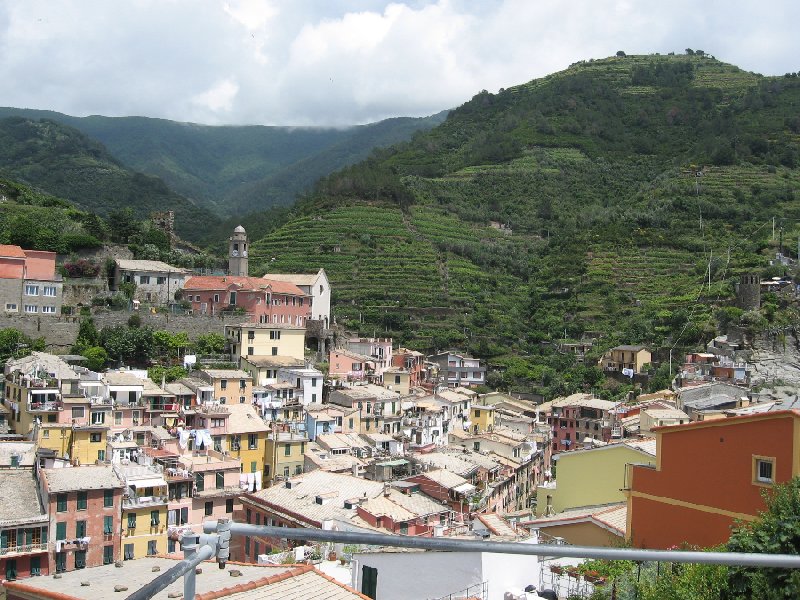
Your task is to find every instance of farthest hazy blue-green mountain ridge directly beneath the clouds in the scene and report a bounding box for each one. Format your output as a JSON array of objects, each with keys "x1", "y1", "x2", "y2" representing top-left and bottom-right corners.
[{"x1": 0, "y1": 108, "x2": 446, "y2": 218}]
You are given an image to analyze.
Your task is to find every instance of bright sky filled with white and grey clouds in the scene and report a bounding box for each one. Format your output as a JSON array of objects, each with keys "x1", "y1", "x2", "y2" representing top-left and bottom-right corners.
[{"x1": 0, "y1": 0, "x2": 800, "y2": 126}]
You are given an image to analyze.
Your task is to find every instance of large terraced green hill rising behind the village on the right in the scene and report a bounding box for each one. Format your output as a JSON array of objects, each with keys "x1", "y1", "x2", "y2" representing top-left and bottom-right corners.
[{"x1": 251, "y1": 52, "x2": 800, "y2": 394}]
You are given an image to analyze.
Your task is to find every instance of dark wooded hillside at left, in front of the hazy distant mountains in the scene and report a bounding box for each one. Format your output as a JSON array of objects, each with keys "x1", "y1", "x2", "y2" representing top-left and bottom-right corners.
[{"x1": 0, "y1": 117, "x2": 215, "y2": 240}]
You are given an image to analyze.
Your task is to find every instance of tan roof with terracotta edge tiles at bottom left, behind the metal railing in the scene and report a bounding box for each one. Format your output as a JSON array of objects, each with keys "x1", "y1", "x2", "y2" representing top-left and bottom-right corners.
[{"x1": 5, "y1": 556, "x2": 366, "y2": 600}]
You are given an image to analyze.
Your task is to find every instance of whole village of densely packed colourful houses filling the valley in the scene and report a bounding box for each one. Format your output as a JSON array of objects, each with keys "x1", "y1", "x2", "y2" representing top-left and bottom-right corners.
[{"x1": 0, "y1": 226, "x2": 800, "y2": 600}]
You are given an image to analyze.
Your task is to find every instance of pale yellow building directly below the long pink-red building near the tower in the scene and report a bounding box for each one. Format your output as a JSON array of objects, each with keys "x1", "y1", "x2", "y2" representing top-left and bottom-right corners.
[{"x1": 225, "y1": 323, "x2": 306, "y2": 361}]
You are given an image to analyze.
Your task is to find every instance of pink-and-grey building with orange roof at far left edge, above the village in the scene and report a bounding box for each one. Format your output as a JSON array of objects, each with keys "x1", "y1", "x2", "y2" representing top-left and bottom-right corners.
[{"x1": 0, "y1": 244, "x2": 63, "y2": 315}]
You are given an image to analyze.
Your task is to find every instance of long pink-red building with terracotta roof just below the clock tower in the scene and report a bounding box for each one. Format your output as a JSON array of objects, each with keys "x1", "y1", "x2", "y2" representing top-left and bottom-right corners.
[{"x1": 183, "y1": 275, "x2": 311, "y2": 327}]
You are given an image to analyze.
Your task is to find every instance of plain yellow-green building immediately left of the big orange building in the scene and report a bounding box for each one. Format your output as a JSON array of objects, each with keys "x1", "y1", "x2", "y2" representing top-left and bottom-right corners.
[{"x1": 536, "y1": 439, "x2": 656, "y2": 516}]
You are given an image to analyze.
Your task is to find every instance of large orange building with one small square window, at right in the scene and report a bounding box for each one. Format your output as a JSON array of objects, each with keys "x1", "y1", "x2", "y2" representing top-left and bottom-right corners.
[{"x1": 626, "y1": 410, "x2": 800, "y2": 548}]
